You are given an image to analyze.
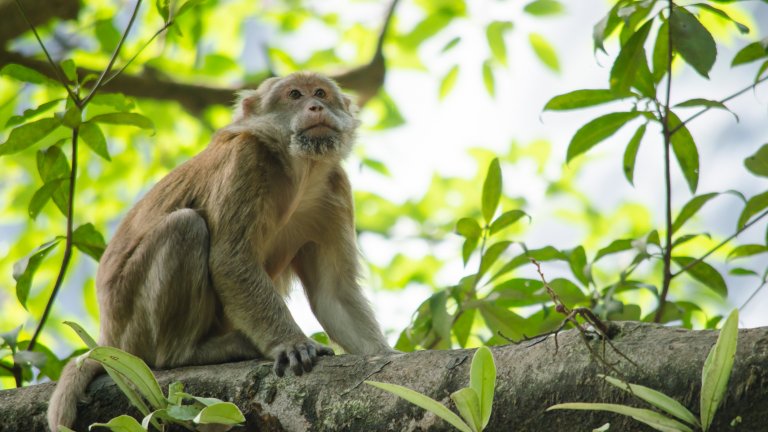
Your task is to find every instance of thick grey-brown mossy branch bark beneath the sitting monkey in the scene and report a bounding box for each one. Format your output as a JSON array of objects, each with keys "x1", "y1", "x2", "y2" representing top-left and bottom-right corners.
[{"x1": 0, "y1": 322, "x2": 768, "y2": 432}]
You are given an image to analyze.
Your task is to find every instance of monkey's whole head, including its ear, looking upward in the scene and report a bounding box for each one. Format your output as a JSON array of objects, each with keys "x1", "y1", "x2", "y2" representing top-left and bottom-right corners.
[{"x1": 235, "y1": 72, "x2": 360, "y2": 159}]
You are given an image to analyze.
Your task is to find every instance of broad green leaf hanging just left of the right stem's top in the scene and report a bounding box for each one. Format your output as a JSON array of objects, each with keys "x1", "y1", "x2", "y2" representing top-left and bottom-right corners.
[{"x1": 610, "y1": 20, "x2": 655, "y2": 97}]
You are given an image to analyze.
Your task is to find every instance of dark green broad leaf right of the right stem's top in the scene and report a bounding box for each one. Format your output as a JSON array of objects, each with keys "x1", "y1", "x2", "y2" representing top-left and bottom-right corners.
[{"x1": 669, "y1": 6, "x2": 717, "y2": 78}]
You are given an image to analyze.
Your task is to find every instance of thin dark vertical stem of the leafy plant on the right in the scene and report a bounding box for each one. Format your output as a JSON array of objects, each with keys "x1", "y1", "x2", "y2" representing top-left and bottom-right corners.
[{"x1": 653, "y1": 0, "x2": 675, "y2": 322}]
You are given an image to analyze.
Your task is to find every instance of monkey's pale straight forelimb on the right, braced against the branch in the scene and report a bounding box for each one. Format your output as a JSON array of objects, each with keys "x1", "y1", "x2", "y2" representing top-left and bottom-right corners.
[{"x1": 294, "y1": 240, "x2": 392, "y2": 354}]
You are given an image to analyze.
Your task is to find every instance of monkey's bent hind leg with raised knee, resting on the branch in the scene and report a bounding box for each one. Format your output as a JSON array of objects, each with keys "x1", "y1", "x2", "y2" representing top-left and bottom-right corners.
[{"x1": 112, "y1": 209, "x2": 258, "y2": 368}]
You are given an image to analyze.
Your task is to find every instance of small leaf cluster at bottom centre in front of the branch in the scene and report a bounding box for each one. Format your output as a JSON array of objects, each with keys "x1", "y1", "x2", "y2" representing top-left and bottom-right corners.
[{"x1": 365, "y1": 347, "x2": 496, "y2": 432}]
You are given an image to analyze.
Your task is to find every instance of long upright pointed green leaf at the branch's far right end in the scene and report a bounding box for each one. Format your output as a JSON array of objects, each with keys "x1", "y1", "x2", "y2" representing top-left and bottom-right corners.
[{"x1": 701, "y1": 309, "x2": 739, "y2": 432}]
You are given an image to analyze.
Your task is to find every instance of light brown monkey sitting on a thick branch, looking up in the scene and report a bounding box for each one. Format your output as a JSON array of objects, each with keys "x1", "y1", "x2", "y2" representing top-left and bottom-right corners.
[{"x1": 48, "y1": 72, "x2": 394, "y2": 431}]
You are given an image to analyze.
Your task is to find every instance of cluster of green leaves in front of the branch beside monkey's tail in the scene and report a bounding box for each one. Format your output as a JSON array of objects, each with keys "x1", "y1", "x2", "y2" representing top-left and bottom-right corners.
[{"x1": 60, "y1": 322, "x2": 245, "y2": 432}]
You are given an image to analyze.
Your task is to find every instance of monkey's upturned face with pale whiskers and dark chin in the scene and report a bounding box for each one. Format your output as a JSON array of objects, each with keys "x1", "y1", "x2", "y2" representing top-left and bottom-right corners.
[{"x1": 259, "y1": 73, "x2": 359, "y2": 159}]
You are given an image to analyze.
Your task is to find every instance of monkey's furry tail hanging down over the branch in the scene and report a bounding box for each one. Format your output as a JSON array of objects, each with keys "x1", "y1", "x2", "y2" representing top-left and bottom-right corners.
[{"x1": 48, "y1": 359, "x2": 104, "y2": 432}]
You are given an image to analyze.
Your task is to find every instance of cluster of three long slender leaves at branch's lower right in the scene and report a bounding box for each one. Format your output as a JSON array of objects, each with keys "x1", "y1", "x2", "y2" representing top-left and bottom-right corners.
[{"x1": 547, "y1": 309, "x2": 739, "y2": 432}]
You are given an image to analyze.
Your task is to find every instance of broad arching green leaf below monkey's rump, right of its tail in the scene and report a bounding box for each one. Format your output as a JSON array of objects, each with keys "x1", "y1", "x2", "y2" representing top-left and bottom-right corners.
[{"x1": 86, "y1": 347, "x2": 168, "y2": 409}]
